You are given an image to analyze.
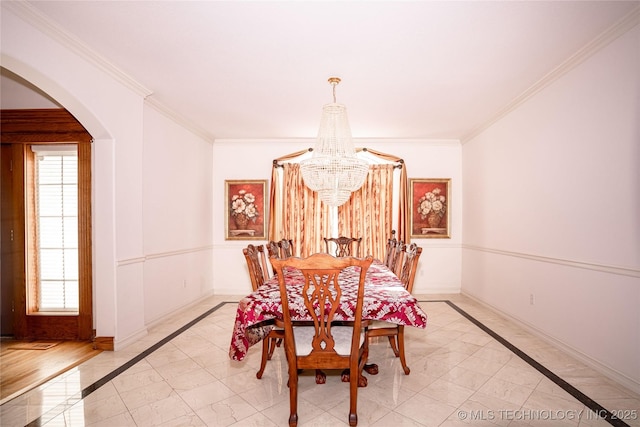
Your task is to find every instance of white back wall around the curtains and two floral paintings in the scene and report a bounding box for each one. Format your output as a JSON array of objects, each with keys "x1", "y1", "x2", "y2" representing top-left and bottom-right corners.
[{"x1": 212, "y1": 139, "x2": 462, "y2": 295}]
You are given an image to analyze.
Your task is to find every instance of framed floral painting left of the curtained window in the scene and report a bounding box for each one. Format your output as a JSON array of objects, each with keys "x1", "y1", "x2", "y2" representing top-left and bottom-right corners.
[{"x1": 224, "y1": 180, "x2": 268, "y2": 240}]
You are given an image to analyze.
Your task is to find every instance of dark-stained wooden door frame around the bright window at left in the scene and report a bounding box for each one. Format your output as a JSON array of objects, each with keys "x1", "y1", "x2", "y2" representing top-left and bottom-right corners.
[{"x1": 0, "y1": 109, "x2": 94, "y2": 340}]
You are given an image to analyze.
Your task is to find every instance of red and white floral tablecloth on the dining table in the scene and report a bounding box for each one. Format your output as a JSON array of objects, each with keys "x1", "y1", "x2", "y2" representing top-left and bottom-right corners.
[{"x1": 229, "y1": 260, "x2": 427, "y2": 360}]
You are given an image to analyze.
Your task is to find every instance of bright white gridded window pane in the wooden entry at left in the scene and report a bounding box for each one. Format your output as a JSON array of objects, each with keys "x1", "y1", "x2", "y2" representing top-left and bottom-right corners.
[{"x1": 33, "y1": 146, "x2": 79, "y2": 311}]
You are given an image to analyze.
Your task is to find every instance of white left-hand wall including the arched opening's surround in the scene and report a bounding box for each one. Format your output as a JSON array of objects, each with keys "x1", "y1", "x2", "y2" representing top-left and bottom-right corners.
[{"x1": 1, "y1": 2, "x2": 212, "y2": 349}]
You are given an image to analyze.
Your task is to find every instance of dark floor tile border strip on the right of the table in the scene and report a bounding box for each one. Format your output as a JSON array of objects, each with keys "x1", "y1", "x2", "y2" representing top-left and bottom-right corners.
[{"x1": 419, "y1": 300, "x2": 630, "y2": 427}]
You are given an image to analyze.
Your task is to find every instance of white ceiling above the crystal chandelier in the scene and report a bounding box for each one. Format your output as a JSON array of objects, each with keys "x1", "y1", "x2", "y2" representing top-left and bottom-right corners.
[{"x1": 5, "y1": 1, "x2": 640, "y2": 139}]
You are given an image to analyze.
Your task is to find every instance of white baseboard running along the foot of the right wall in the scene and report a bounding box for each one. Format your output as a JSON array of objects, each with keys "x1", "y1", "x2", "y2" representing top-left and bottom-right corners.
[{"x1": 460, "y1": 291, "x2": 640, "y2": 394}]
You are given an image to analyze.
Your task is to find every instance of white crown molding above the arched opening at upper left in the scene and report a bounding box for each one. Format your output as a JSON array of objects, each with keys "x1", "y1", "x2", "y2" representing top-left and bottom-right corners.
[{"x1": 2, "y1": 0, "x2": 153, "y2": 98}]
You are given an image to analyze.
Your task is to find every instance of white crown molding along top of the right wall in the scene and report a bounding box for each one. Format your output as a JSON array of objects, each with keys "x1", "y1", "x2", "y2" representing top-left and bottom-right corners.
[{"x1": 460, "y1": 6, "x2": 640, "y2": 144}]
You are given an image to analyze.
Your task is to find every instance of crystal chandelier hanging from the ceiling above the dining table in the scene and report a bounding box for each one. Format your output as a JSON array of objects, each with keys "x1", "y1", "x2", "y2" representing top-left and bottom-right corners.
[{"x1": 300, "y1": 77, "x2": 369, "y2": 206}]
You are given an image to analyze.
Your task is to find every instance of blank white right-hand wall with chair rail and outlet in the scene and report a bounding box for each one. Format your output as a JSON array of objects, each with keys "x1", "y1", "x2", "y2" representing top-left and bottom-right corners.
[{"x1": 462, "y1": 25, "x2": 640, "y2": 391}]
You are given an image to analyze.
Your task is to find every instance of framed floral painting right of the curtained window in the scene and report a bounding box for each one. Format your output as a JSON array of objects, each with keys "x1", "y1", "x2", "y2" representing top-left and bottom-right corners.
[{"x1": 409, "y1": 178, "x2": 451, "y2": 238}]
